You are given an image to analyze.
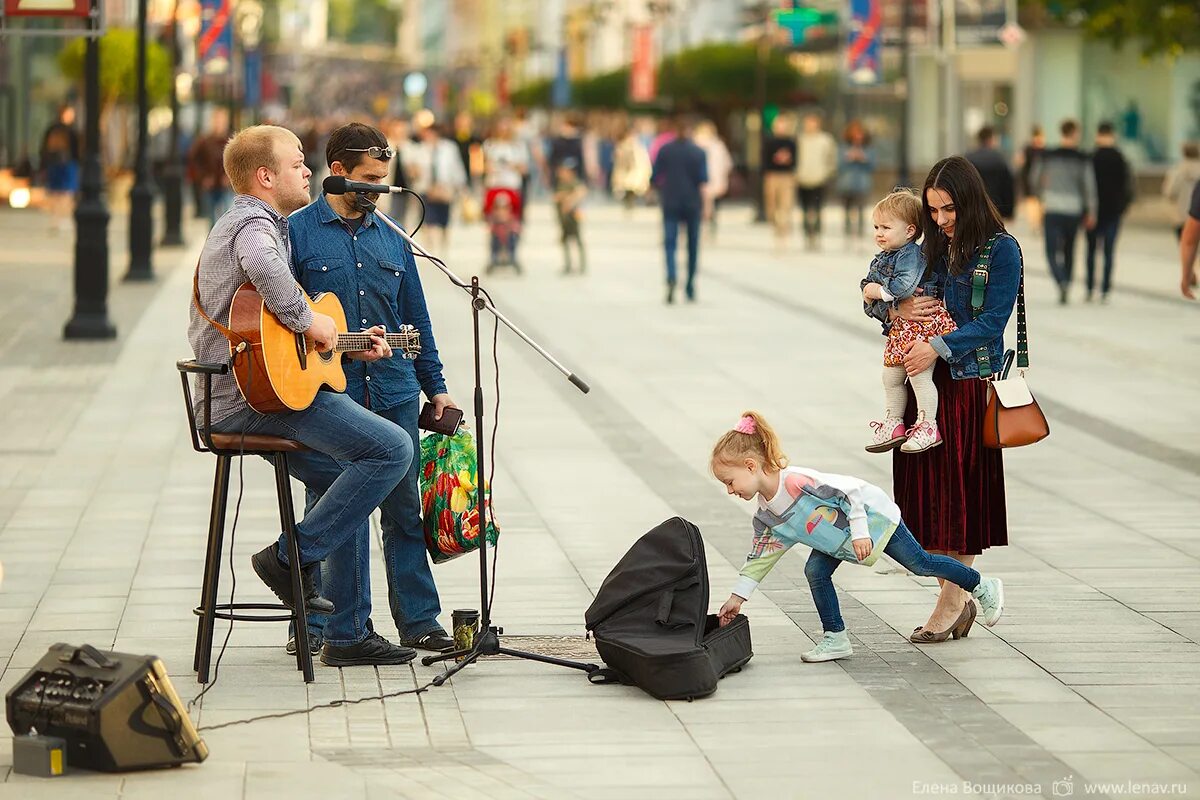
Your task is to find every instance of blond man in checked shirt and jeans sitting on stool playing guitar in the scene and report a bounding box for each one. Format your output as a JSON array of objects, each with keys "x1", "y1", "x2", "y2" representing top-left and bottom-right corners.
[{"x1": 188, "y1": 125, "x2": 416, "y2": 664}]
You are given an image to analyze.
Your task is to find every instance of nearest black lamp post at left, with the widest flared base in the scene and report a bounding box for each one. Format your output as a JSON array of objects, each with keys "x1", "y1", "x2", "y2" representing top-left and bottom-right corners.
[{"x1": 62, "y1": 0, "x2": 116, "y2": 339}]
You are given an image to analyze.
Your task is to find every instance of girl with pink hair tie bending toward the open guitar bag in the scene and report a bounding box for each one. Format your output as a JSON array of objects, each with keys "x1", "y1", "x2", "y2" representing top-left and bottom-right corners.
[{"x1": 712, "y1": 411, "x2": 1004, "y2": 661}]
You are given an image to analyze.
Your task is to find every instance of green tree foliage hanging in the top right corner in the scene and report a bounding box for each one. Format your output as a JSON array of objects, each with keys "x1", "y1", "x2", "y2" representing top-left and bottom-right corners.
[{"x1": 1021, "y1": 0, "x2": 1200, "y2": 56}]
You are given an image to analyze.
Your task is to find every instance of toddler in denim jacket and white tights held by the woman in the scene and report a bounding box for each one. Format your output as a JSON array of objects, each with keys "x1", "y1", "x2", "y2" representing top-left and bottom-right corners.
[{"x1": 860, "y1": 190, "x2": 956, "y2": 452}]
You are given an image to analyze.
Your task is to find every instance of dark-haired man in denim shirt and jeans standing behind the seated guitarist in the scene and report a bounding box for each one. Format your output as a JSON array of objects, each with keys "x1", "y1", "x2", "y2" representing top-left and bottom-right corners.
[{"x1": 289, "y1": 122, "x2": 455, "y2": 666}]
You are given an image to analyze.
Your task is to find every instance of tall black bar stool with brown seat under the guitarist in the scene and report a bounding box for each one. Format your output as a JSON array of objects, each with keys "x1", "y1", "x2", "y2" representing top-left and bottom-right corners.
[{"x1": 175, "y1": 360, "x2": 313, "y2": 684}]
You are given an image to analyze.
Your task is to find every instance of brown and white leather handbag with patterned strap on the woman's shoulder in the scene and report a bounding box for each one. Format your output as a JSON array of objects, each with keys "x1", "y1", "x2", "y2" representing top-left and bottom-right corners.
[{"x1": 971, "y1": 237, "x2": 1050, "y2": 449}]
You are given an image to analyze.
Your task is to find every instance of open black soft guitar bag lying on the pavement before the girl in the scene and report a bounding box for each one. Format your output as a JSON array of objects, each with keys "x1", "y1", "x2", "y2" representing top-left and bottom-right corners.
[{"x1": 584, "y1": 517, "x2": 754, "y2": 700}]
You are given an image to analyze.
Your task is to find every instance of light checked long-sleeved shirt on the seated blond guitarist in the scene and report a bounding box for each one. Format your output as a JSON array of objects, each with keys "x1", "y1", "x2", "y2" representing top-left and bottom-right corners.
[{"x1": 187, "y1": 194, "x2": 312, "y2": 422}]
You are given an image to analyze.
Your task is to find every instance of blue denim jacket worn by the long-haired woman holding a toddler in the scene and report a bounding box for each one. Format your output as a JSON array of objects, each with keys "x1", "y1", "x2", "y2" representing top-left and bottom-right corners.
[{"x1": 929, "y1": 233, "x2": 1024, "y2": 380}]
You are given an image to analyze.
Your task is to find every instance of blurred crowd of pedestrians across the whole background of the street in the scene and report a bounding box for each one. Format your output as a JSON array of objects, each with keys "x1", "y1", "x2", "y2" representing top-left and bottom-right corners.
[{"x1": 23, "y1": 97, "x2": 1200, "y2": 302}]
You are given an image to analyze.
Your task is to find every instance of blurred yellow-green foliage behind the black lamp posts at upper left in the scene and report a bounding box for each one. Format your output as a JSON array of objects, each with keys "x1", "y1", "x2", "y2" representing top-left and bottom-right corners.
[{"x1": 59, "y1": 28, "x2": 172, "y2": 106}]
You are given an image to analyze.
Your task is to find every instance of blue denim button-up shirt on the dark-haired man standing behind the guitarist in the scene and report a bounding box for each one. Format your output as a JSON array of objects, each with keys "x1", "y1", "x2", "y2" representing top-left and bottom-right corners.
[{"x1": 289, "y1": 194, "x2": 446, "y2": 410}]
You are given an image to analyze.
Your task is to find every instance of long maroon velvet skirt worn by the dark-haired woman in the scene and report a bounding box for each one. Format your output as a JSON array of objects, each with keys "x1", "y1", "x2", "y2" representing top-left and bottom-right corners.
[{"x1": 892, "y1": 360, "x2": 1008, "y2": 555}]
